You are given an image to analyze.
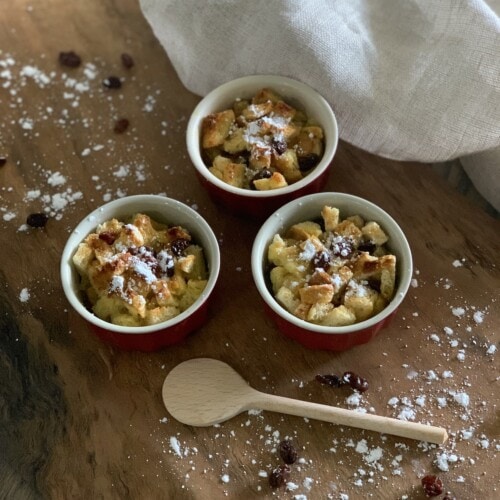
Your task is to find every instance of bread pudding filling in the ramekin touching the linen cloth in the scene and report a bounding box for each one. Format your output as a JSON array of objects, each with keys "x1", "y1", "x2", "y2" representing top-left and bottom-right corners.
[{"x1": 201, "y1": 88, "x2": 324, "y2": 191}]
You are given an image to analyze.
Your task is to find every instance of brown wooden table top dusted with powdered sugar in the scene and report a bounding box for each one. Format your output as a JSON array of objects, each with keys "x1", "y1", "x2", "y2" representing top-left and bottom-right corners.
[{"x1": 0, "y1": 0, "x2": 500, "y2": 499}]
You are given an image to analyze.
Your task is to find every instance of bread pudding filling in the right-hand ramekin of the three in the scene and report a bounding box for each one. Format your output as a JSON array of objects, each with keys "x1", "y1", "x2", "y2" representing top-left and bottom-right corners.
[{"x1": 267, "y1": 206, "x2": 396, "y2": 326}]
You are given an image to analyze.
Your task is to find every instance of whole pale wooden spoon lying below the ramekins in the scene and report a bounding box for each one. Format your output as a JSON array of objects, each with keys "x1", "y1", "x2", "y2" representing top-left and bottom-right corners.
[{"x1": 162, "y1": 358, "x2": 448, "y2": 444}]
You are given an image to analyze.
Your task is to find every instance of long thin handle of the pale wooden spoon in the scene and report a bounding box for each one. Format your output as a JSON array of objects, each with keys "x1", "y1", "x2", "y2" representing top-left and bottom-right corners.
[{"x1": 253, "y1": 391, "x2": 448, "y2": 444}]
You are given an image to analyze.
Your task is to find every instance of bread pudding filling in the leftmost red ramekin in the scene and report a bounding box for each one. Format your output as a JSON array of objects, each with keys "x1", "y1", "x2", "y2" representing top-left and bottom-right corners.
[{"x1": 72, "y1": 213, "x2": 208, "y2": 326}]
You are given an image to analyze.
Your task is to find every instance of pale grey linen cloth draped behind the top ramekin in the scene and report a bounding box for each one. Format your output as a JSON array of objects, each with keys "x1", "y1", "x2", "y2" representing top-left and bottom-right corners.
[{"x1": 140, "y1": 0, "x2": 500, "y2": 209}]
